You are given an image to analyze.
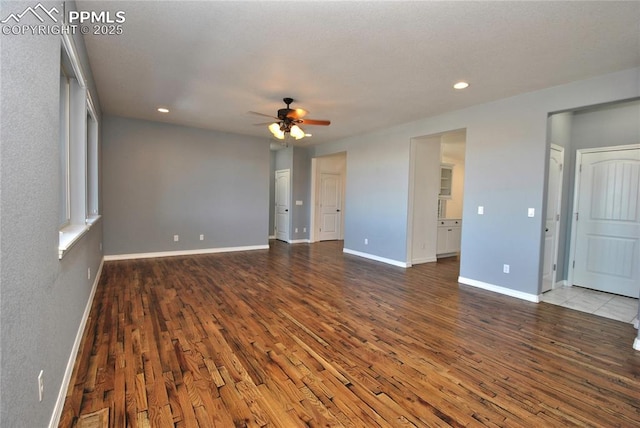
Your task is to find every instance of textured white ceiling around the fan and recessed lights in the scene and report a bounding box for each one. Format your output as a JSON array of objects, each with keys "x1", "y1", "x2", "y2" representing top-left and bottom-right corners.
[{"x1": 76, "y1": 1, "x2": 640, "y2": 144}]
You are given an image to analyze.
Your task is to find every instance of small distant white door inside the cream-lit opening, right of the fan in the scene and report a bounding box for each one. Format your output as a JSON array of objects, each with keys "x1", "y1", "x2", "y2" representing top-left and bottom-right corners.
[{"x1": 318, "y1": 172, "x2": 342, "y2": 241}]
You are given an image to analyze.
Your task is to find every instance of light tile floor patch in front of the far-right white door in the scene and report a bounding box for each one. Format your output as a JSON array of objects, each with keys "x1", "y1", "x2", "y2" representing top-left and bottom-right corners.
[{"x1": 542, "y1": 286, "x2": 638, "y2": 323}]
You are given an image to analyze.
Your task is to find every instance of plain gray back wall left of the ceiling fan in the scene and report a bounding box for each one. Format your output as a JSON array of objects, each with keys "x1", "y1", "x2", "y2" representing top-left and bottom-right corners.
[{"x1": 102, "y1": 116, "x2": 270, "y2": 255}]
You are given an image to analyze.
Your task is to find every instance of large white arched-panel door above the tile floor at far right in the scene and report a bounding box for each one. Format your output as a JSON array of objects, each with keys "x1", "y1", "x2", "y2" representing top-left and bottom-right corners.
[{"x1": 573, "y1": 146, "x2": 640, "y2": 298}]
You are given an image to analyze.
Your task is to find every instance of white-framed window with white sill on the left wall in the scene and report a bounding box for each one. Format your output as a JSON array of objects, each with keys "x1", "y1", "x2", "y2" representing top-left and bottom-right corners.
[{"x1": 58, "y1": 34, "x2": 99, "y2": 258}]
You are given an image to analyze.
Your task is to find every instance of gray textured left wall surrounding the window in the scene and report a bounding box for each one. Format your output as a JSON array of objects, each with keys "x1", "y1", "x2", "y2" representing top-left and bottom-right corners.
[{"x1": 0, "y1": 1, "x2": 102, "y2": 427}]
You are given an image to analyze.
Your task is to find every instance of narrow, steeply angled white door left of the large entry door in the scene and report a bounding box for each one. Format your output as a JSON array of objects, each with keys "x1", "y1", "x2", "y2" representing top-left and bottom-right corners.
[{"x1": 542, "y1": 145, "x2": 564, "y2": 293}]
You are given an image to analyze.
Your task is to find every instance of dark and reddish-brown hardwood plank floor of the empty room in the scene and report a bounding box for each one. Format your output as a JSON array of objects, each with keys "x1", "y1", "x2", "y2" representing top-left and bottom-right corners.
[{"x1": 60, "y1": 242, "x2": 640, "y2": 428}]
